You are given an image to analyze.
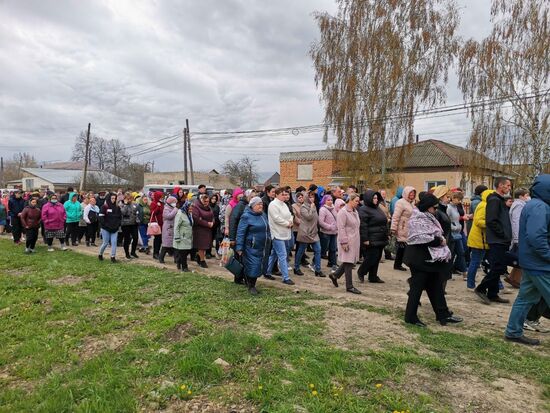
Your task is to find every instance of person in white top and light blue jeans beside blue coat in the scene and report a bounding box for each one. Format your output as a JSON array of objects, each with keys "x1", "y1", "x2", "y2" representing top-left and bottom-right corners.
[{"x1": 266, "y1": 188, "x2": 294, "y2": 285}]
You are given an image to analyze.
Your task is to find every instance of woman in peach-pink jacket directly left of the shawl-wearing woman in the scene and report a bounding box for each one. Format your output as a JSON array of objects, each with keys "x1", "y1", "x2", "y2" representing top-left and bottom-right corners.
[{"x1": 391, "y1": 186, "x2": 416, "y2": 271}]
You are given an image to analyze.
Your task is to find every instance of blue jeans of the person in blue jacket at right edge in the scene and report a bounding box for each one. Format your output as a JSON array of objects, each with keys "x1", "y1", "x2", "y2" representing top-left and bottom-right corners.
[{"x1": 504, "y1": 269, "x2": 550, "y2": 337}]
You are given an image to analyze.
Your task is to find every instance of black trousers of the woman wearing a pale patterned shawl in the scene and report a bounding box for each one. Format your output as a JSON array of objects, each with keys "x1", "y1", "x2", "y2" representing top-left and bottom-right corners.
[{"x1": 405, "y1": 267, "x2": 452, "y2": 323}]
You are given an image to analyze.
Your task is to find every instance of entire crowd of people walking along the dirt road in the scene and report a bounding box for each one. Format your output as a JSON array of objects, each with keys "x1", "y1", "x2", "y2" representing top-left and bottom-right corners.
[{"x1": 0, "y1": 175, "x2": 550, "y2": 345}]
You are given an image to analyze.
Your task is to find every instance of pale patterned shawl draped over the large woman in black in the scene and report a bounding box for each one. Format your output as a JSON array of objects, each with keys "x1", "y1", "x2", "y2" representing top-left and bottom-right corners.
[{"x1": 407, "y1": 208, "x2": 451, "y2": 262}]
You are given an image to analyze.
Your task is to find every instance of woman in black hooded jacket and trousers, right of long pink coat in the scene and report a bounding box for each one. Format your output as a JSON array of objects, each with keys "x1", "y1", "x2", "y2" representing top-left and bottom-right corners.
[{"x1": 357, "y1": 190, "x2": 388, "y2": 283}]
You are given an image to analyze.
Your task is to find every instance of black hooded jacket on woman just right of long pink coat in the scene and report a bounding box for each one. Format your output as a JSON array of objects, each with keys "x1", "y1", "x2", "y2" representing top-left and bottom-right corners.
[{"x1": 358, "y1": 190, "x2": 388, "y2": 247}]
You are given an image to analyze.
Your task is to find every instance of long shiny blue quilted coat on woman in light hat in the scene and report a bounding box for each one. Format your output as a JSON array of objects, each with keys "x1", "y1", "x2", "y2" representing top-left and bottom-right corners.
[{"x1": 235, "y1": 207, "x2": 271, "y2": 278}]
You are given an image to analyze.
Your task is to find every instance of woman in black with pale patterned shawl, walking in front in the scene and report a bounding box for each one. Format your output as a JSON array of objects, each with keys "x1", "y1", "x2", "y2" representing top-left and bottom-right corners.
[{"x1": 404, "y1": 194, "x2": 462, "y2": 327}]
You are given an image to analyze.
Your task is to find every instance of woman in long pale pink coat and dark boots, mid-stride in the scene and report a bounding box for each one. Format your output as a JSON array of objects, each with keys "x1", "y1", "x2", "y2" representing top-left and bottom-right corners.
[{"x1": 329, "y1": 193, "x2": 361, "y2": 294}]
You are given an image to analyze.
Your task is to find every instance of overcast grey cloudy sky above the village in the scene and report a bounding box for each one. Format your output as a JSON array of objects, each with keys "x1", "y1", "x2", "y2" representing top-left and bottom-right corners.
[{"x1": 0, "y1": 0, "x2": 490, "y2": 172}]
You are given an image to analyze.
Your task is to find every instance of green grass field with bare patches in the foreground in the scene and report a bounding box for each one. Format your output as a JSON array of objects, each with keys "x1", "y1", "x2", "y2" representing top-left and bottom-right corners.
[{"x1": 0, "y1": 240, "x2": 550, "y2": 413}]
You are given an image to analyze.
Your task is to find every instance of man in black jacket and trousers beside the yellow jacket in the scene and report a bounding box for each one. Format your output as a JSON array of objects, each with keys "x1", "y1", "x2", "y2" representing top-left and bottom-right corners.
[{"x1": 474, "y1": 177, "x2": 512, "y2": 304}]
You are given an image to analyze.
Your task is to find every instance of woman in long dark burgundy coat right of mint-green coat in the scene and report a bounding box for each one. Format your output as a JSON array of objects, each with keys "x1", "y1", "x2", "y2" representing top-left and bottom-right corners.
[{"x1": 193, "y1": 194, "x2": 214, "y2": 268}]
